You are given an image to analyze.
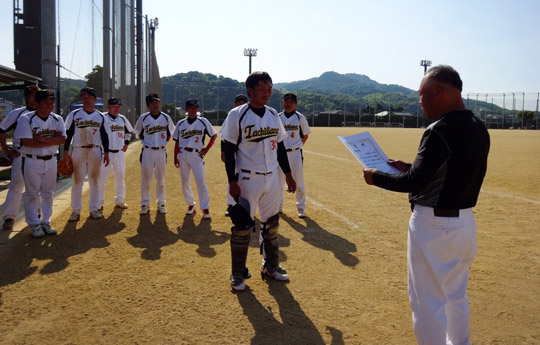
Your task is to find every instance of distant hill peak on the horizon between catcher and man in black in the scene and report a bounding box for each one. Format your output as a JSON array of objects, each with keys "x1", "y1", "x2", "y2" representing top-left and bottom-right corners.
[{"x1": 274, "y1": 72, "x2": 416, "y2": 97}]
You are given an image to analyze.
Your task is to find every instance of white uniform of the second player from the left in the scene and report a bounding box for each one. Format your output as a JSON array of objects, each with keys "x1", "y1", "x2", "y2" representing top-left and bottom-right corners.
[{"x1": 15, "y1": 112, "x2": 66, "y2": 226}]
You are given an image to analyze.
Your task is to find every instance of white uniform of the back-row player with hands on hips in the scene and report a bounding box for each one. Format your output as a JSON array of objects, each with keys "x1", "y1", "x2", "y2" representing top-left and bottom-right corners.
[{"x1": 173, "y1": 116, "x2": 217, "y2": 210}]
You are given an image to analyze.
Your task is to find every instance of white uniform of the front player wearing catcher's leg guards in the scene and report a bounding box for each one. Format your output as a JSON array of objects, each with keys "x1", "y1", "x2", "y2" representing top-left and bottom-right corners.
[{"x1": 221, "y1": 104, "x2": 287, "y2": 223}]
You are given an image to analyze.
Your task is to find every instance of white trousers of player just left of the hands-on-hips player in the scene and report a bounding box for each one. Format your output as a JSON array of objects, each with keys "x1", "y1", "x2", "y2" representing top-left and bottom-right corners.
[{"x1": 141, "y1": 147, "x2": 167, "y2": 206}]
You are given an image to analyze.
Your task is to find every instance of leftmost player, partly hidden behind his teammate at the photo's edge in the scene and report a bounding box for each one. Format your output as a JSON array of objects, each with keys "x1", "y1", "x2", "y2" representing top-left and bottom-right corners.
[{"x1": 0, "y1": 85, "x2": 39, "y2": 230}]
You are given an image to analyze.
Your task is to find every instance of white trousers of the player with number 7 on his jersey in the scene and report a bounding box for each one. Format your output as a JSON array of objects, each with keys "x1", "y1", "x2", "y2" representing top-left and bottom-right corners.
[{"x1": 71, "y1": 147, "x2": 102, "y2": 214}]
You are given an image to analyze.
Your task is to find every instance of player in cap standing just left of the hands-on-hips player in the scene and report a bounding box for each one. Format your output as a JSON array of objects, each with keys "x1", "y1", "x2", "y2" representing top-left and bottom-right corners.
[{"x1": 134, "y1": 93, "x2": 174, "y2": 215}]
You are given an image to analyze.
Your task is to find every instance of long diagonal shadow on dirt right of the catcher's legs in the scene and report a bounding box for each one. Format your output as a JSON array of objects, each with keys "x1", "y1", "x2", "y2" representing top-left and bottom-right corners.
[{"x1": 281, "y1": 214, "x2": 360, "y2": 267}]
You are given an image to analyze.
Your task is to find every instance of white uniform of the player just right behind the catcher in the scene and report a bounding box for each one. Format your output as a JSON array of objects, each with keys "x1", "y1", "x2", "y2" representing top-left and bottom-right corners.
[{"x1": 279, "y1": 111, "x2": 311, "y2": 209}]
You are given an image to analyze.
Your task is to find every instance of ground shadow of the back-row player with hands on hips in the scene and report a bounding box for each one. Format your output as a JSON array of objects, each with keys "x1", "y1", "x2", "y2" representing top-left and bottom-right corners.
[{"x1": 177, "y1": 215, "x2": 231, "y2": 258}]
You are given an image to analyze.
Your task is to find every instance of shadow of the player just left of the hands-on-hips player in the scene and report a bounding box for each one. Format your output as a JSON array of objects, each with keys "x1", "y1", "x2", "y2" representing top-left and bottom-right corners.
[{"x1": 128, "y1": 212, "x2": 180, "y2": 260}]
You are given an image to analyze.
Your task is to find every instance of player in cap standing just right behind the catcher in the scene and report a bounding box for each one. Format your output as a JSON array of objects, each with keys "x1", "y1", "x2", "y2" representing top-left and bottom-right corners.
[{"x1": 279, "y1": 93, "x2": 311, "y2": 218}]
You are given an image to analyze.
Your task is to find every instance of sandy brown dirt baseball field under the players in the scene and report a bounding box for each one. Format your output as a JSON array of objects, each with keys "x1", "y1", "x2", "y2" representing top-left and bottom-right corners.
[{"x1": 0, "y1": 128, "x2": 540, "y2": 345}]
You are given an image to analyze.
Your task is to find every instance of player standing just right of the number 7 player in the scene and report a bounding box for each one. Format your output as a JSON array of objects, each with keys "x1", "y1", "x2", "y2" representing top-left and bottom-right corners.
[{"x1": 99, "y1": 98, "x2": 133, "y2": 210}]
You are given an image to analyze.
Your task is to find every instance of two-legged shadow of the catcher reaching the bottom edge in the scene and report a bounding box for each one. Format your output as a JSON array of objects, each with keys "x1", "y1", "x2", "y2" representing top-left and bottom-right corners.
[{"x1": 236, "y1": 281, "x2": 324, "y2": 345}]
